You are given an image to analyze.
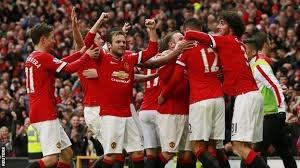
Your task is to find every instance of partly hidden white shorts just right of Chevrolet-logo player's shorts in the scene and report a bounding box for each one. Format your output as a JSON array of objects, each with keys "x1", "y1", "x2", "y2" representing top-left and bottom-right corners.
[{"x1": 139, "y1": 110, "x2": 160, "y2": 149}]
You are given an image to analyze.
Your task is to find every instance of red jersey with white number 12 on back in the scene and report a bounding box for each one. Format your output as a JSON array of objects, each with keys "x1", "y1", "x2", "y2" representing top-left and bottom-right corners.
[{"x1": 176, "y1": 44, "x2": 223, "y2": 104}]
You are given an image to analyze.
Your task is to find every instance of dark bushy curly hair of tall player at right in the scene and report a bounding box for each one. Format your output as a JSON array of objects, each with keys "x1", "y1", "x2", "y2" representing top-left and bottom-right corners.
[{"x1": 219, "y1": 11, "x2": 245, "y2": 38}]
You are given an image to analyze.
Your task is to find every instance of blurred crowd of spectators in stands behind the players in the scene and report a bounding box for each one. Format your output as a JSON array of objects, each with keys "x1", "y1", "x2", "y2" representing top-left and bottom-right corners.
[{"x1": 0, "y1": 0, "x2": 300, "y2": 157}]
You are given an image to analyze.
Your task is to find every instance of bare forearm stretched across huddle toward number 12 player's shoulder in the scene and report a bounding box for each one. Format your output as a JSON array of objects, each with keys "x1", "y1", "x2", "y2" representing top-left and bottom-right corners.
[{"x1": 138, "y1": 41, "x2": 194, "y2": 69}]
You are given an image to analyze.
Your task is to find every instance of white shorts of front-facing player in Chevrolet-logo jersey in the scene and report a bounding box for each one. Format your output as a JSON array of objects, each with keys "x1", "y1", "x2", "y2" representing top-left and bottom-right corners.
[{"x1": 100, "y1": 116, "x2": 144, "y2": 154}]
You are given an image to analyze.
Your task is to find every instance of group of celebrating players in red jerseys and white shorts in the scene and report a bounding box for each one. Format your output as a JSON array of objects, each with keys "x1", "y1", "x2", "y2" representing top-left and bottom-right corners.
[{"x1": 25, "y1": 6, "x2": 296, "y2": 168}]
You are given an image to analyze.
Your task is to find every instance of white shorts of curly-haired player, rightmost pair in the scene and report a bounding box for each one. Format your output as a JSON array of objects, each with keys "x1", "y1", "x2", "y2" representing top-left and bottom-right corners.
[{"x1": 231, "y1": 91, "x2": 264, "y2": 143}]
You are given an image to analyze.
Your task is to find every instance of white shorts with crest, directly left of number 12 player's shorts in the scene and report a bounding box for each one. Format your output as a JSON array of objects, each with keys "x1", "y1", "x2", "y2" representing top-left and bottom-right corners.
[{"x1": 157, "y1": 114, "x2": 192, "y2": 153}]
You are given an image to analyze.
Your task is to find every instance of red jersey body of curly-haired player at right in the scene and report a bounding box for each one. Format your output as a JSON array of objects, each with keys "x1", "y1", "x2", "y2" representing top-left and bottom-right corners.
[{"x1": 210, "y1": 35, "x2": 258, "y2": 96}]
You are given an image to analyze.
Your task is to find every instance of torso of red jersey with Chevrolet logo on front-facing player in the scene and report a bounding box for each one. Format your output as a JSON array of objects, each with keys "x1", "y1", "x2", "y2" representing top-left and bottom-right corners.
[{"x1": 98, "y1": 53, "x2": 143, "y2": 117}]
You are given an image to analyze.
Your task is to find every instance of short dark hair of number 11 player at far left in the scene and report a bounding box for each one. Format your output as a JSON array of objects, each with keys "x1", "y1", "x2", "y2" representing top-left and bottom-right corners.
[{"x1": 30, "y1": 23, "x2": 54, "y2": 45}]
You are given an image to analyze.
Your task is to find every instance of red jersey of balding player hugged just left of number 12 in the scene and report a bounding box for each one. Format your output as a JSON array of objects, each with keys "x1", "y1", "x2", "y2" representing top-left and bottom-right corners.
[{"x1": 158, "y1": 62, "x2": 189, "y2": 114}]
